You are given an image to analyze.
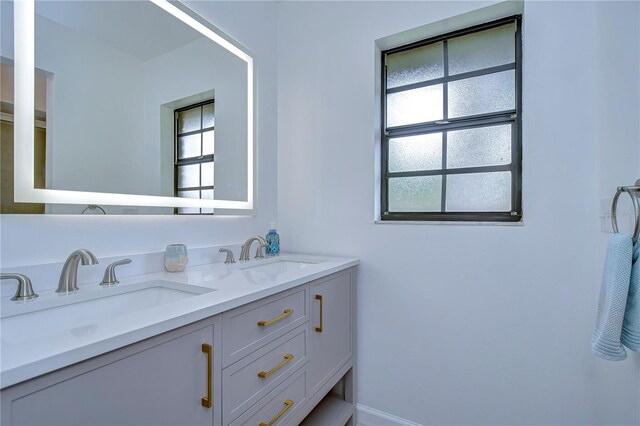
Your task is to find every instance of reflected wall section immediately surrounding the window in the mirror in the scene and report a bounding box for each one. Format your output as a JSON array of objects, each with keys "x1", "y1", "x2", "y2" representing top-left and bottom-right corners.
[{"x1": 145, "y1": 38, "x2": 247, "y2": 201}]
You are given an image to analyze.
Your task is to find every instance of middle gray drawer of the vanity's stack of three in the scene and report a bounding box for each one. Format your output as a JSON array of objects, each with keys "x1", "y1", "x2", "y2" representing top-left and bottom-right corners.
[{"x1": 222, "y1": 324, "x2": 309, "y2": 422}]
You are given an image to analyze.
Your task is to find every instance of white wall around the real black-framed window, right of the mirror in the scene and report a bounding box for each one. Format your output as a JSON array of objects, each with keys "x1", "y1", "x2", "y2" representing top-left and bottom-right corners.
[{"x1": 278, "y1": 2, "x2": 640, "y2": 424}]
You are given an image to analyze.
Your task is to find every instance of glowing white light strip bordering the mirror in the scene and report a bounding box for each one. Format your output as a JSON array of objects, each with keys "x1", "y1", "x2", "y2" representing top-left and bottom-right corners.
[{"x1": 13, "y1": 0, "x2": 255, "y2": 210}]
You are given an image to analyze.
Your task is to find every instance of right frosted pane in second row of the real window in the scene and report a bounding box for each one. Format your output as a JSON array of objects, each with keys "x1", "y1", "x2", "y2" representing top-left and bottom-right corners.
[{"x1": 449, "y1": 70, "x2": 516, "y2": 118}]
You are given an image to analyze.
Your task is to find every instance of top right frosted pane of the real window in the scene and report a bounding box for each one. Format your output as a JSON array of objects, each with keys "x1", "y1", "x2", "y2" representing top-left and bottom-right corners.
[{"x1": 448, "y1": 23, "x2": 516, "y2": 75}]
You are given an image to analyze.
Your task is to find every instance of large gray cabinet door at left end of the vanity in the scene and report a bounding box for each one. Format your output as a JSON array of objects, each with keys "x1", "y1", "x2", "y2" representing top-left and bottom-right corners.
[{"x1": 3, "y1": 325, "x2": 221, "y2": 425}]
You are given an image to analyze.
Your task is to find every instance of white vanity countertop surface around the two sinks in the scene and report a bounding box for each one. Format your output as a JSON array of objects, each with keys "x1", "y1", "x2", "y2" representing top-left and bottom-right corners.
[{"x1": 0, "y1": 254, "x2": 358, "y2": 388}]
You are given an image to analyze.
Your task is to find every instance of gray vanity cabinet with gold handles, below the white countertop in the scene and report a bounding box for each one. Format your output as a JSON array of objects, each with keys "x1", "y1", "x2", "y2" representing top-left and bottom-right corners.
[{"x1": 0, "y1": 268, "x2": 356, "y2": 426}]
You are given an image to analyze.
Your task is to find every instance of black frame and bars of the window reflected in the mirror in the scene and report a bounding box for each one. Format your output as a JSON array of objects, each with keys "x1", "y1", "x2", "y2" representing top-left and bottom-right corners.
[{"x1": 173, "y1": 99, "x2": 215, "y2": 216}]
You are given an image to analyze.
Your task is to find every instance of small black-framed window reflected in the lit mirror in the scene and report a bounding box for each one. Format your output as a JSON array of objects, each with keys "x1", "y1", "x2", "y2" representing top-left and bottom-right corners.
[{"x1": 174, "y1": 99, "x2": 215, "y2": 214}]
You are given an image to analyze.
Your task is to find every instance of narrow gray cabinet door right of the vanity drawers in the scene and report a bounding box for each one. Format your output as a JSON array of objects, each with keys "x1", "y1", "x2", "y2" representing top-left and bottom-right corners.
[{"x1": 308, "y1": 270, "x2": 354, "y2": 395}]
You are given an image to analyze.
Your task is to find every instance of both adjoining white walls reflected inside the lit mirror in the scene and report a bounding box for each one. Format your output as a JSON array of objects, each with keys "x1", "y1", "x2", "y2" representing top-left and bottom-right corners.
[{"x1": 9, "y1": 8, "x2": 247, "y2": 214}]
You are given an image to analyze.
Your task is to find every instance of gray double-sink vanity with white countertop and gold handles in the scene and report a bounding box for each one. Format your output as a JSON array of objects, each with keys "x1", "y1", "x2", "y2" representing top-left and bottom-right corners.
[{"x1": 0, "y1": 255, "x2": 358, "y2": 426}]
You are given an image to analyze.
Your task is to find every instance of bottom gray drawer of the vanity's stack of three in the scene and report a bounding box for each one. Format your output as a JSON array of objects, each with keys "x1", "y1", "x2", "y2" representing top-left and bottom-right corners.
[{"x1": 225, "y1": 367, "x2": 309, "y2": 426}]
